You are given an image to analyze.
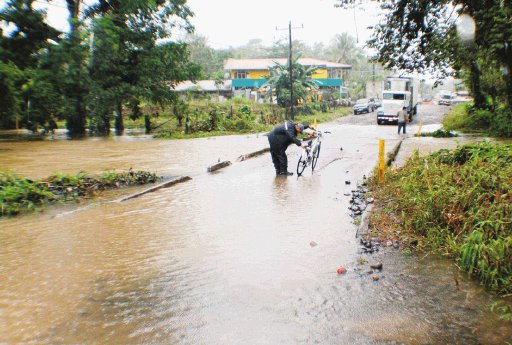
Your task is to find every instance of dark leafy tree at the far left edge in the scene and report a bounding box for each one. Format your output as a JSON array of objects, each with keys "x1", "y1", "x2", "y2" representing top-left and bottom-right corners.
[{"x1": 0, "y1": 0, "x2": 60, "y2": 128}]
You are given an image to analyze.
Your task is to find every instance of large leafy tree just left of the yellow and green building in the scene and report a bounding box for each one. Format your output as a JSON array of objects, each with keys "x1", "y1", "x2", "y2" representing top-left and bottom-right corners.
[{"x1": 89, "y1": 0, "x2": 198, "y2": 134}]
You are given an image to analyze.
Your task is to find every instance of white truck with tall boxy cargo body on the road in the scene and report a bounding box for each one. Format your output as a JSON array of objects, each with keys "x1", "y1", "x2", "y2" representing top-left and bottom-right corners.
[{"x1": 377, "y1": 76, "x2": 419, "y2": 125}]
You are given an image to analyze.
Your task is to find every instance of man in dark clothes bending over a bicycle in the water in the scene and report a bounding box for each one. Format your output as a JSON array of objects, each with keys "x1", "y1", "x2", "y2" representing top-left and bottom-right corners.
[{"x1": 268, "y1": 121, "x2": 312, "y2": 176}]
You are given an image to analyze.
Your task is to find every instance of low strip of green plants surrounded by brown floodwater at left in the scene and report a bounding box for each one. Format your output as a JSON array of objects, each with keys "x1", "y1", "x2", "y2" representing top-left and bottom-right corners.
[{"x1": 0, "y1": 169, "x2": 158, "y2": 216}]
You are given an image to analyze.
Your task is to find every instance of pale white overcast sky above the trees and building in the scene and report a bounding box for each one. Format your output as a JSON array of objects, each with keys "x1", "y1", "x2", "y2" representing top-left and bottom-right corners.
[{"x1": 0, "y1": 0, "x2": 379, "y2": 49}]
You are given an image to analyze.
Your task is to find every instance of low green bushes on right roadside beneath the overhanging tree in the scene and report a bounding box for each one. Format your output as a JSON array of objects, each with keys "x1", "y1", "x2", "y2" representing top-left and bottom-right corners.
[{"x1": 443, "y1": 104, "x2": 512, "y2": 138}]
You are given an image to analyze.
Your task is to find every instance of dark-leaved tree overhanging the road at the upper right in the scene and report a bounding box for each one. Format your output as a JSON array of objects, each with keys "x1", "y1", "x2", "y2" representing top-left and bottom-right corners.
[{"x1": 368, "y1": 0, "x2": 512, "y2": 107}]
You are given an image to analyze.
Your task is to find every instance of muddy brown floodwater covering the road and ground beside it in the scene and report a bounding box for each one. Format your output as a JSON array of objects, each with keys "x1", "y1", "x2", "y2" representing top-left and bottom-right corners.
[{"x1": 0, "y1": 106, "x2": 512, "y2": 344}]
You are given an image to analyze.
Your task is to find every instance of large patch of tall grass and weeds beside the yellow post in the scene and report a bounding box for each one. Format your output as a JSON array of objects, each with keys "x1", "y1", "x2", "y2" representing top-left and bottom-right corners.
[{"x1": 372, "y1": 142, "x2": 512, "y2": 295}]
